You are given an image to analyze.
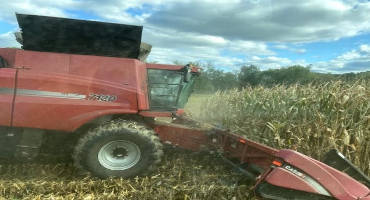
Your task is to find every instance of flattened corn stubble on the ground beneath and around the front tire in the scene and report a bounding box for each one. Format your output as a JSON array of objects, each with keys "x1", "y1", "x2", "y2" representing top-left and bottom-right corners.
[{"x1": 0, "y1": 148, "x2": 253, "y2": 200}]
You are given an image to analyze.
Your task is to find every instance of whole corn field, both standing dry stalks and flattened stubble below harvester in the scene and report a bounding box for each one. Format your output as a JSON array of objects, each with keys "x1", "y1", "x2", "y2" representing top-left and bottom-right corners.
[{"x1": 0, "y1": 82, "x2": 370, "y2": 200}]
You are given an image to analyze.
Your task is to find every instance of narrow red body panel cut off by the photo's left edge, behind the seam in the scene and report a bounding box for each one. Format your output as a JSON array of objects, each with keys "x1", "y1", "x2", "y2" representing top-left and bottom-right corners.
[{"x1": 0, "y1": 68, "x2": 16, "y2": 127}]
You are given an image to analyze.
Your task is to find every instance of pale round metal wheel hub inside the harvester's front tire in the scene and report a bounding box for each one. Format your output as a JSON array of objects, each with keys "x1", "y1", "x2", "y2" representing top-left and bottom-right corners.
[{"x1": 98, "y1": 140, "x2": 141, "y2": 170}]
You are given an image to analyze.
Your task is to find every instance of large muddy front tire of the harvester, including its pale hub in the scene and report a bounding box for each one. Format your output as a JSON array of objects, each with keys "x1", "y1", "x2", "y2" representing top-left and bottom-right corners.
[{"x1": 73, "y1": 120, "x2": 163, "y2": 178}]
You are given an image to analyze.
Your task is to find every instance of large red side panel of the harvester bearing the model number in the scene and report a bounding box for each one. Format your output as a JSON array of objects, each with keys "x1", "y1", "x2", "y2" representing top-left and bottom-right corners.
[{"x1": 13, "y1": 71, "x2": 137, "y2": 131}]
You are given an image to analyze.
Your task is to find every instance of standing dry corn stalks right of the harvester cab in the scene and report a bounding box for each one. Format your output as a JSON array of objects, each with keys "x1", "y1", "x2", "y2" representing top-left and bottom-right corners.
[{"x1": 192, "y1": 81, "x2": 370, "y2": 175}]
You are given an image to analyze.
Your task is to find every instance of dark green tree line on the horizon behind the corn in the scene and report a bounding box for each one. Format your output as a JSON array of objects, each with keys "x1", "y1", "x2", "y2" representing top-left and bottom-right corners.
[{"x1": 194, "y1": 64, "x2": 370, "y2": 93}]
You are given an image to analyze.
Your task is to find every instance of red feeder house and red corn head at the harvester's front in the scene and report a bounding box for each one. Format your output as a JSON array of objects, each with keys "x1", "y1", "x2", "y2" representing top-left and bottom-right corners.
[{"x1": 154, "y1": 119, "x2": 370, "y2": 200}]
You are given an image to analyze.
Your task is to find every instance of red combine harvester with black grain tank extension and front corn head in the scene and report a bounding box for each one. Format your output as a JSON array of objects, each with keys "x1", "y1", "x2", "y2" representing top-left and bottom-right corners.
[{"x1": 0, "y1": 14, "x2": 370, "y2": 200}]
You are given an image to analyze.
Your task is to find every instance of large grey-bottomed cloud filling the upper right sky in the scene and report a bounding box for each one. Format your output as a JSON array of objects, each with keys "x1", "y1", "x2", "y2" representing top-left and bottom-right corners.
[{"x1": 147, "y1": 0, "x2": 370, "y2": 42}]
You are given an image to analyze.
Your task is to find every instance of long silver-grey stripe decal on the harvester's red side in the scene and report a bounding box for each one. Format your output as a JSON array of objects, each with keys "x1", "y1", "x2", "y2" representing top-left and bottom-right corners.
[{"x1": 0, "y1": 88, "x2": 86, "y2": 99}]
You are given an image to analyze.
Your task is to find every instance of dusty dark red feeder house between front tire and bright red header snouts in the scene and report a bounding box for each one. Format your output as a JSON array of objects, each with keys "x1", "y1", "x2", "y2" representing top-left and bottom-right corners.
[{"x1": 154, "y1": 118, "x2": 278, "y2": 169}]
